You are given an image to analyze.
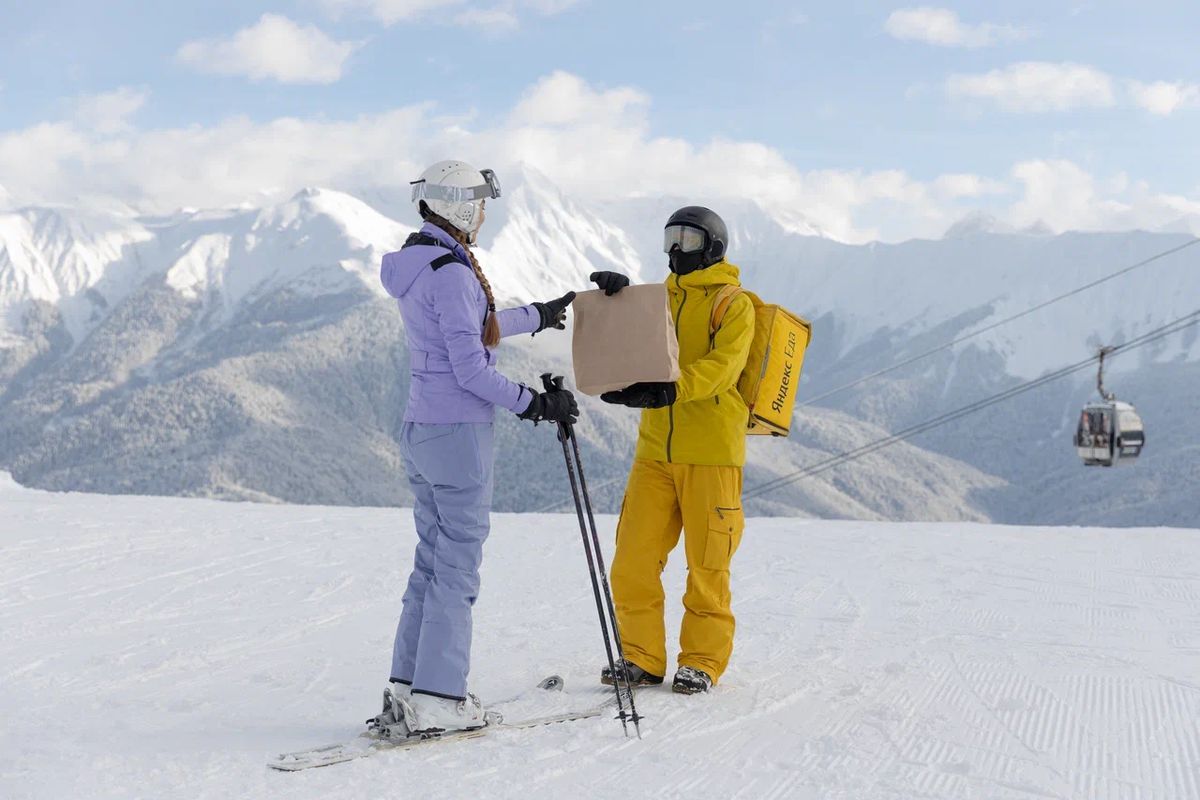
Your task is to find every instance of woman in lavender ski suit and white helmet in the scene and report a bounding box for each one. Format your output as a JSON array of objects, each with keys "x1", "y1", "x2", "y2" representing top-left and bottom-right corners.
[{"x1": 367, "y1": 161, "x2": 578, "y2": 736}]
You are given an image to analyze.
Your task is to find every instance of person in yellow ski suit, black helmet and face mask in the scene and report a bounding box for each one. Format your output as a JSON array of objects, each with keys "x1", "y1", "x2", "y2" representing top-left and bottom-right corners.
[{"x1": 593, "y1": 206, "x2": 755, "y2": 694}]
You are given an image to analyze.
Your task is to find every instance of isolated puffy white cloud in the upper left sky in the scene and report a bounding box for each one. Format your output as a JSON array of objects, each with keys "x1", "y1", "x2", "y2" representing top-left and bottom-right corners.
[{"x1": 176, "y1": 14, "x2": 359, "y2": 84}]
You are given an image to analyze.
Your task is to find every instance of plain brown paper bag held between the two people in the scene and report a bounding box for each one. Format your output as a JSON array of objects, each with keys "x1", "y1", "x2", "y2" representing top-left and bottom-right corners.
[{"x1": 571, "y1": 283, "x2": 679, "y2": 396}]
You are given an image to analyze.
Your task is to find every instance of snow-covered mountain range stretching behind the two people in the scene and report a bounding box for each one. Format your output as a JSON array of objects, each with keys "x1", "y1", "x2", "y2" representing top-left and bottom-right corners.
[{"x1": 0, "y1": 170, "x2": 1200, "y2": 524}]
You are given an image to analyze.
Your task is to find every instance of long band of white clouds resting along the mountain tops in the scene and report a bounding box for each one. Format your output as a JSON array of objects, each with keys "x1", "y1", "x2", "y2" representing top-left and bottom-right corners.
[{"x1": 0, "y1": 72, "x2": 1200, "y2": 242}]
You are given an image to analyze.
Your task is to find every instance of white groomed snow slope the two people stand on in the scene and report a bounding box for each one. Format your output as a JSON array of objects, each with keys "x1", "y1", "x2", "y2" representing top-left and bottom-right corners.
[{"x1": 0, "y1": 476, "x2": 1200, "y2": 800}]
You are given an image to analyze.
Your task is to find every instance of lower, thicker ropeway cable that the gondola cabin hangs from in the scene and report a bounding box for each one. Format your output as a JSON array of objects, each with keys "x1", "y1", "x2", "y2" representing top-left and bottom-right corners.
[{"x1": 742, "y1": 309, "x2": 1200, "y2": 500}]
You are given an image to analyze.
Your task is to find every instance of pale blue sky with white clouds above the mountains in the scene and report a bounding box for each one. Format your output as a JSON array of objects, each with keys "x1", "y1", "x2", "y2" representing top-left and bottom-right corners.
[{"x1": 0, "y1": 0, "x2": 1200, "y2": 239}]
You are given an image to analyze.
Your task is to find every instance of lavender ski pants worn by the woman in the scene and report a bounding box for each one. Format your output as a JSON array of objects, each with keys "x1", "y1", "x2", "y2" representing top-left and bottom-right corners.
[{"x1": 391, "y1": 422, "x2": 492, "y2": 699}]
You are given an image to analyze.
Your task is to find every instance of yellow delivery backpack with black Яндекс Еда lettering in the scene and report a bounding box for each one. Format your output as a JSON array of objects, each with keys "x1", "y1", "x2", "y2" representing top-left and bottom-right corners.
[{"x1": 709, "y1": 287, "x2": 812, "y2": 437}]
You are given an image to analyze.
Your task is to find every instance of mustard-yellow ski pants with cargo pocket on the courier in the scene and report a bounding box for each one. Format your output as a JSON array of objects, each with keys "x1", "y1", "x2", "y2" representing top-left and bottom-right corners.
[{"x1": 612, "y1": 459, "x2": 745, "y2": 684}]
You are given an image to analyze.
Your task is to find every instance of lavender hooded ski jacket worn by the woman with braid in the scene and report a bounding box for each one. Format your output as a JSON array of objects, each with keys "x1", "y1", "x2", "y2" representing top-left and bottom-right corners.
[{"x1": 379, "y1": 223, "x2": 540, "y2": 425}]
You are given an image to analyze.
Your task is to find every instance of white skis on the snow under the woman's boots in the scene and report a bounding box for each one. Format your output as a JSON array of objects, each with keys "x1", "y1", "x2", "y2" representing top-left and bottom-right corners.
[{"x1": 266, "y1": 675, "x2": 614, "y2": 772}]
